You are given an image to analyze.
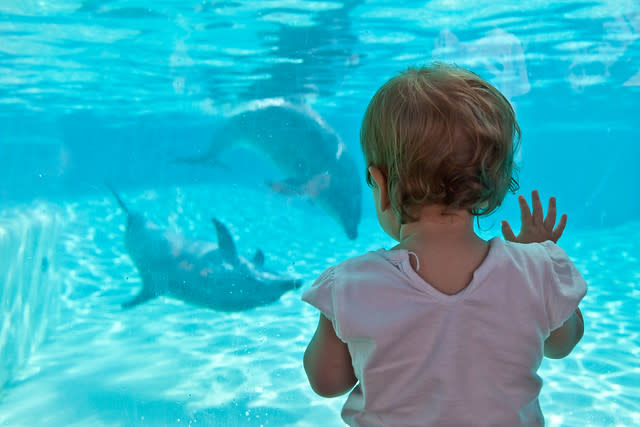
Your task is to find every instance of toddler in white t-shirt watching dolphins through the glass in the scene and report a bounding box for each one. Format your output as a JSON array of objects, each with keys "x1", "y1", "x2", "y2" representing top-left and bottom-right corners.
[{"x1": 302, "y1": 64, "x2": 587, "y2": 427}]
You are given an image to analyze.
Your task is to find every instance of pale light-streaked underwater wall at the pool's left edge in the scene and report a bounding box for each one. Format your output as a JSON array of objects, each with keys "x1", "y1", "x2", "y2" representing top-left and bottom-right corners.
[{"x1": 0, "y1": 204, "x2": 62, "y2": 391}]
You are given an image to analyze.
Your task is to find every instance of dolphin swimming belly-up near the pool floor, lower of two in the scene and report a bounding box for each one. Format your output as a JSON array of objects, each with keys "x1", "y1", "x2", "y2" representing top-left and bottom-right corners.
[{"x1": 111, "y1": 189, "x2": 302, "y2": 311}]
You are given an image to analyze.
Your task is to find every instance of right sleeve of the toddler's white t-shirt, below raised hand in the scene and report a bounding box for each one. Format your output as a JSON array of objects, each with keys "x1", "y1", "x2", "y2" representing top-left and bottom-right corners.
[{"x1": 541, "y1": 240, "x2": 587, "y2": 331}]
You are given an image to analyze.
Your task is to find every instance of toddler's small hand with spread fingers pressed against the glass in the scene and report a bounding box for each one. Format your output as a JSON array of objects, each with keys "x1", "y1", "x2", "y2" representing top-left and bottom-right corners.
[{"x1": 502, "y1": 190, "x2": 567, "y2": 243}]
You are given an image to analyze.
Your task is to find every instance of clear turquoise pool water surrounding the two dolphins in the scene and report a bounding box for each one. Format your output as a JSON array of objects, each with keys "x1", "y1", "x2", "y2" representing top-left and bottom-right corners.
[{"x1": 0, "y1": 0, "x2": 640, "y2": 426}]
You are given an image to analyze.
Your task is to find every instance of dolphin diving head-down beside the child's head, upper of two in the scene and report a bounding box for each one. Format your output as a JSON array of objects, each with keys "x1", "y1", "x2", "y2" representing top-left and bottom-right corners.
[{"x1": 176, "y1": 98, "x2": 362, "y2": 239}]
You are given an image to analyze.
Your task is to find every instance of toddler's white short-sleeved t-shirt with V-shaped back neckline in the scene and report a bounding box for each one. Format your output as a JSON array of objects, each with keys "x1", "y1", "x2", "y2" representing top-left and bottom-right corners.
[{"x1": 302, "y1": 237, "x2": 587, "y2": 427}]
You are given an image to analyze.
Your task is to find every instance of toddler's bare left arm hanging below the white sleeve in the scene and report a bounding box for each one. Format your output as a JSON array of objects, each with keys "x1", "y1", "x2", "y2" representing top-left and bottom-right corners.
[{"x1": 304, "y1": 314, "x2": 358, "y2": 397}]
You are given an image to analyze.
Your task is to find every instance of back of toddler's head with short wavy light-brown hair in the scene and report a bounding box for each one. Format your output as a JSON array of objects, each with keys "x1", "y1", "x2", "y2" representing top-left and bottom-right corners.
[{"x1": 360, "y1": 64, "x2": 520, "y2": 223}]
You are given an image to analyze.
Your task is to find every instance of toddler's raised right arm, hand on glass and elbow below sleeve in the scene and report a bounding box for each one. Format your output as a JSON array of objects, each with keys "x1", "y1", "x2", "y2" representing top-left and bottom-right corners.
[{"x1": 502, "y1": 190, "x2": 584, "y2": 359}]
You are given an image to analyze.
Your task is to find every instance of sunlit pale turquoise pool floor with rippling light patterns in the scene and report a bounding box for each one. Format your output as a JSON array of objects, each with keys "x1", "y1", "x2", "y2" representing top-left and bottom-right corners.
[{"x1": 0, "y1": 186, "x2": 640, "y2": 427}]
